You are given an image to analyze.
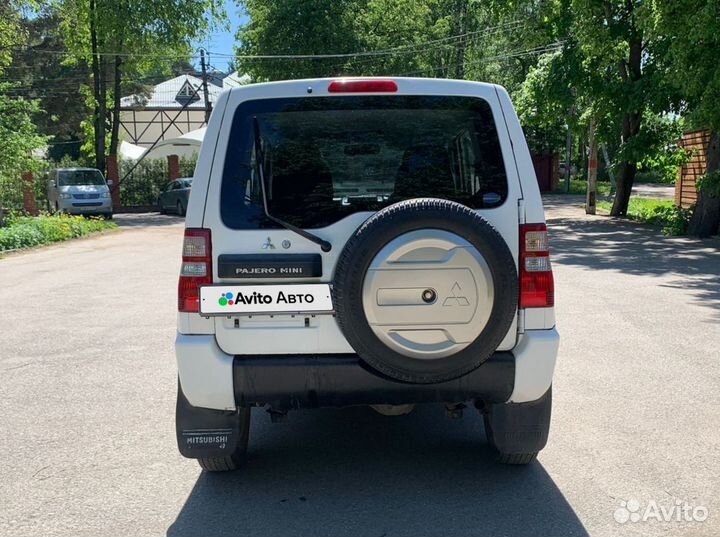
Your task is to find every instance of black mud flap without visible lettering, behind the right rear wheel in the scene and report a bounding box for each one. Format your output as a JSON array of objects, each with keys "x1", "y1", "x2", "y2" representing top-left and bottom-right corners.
[{"x1": 485, "y1": 387, "x2": 552, "y2": 454}]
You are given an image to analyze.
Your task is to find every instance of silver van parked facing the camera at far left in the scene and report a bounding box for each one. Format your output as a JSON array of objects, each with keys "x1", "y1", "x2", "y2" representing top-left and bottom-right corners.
[{"x1": 47, "y1": 168, "x2": 112, "y2": 218}]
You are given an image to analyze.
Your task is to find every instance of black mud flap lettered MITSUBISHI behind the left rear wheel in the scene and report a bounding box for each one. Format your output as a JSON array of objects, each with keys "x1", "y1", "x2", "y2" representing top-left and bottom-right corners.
[{"x1": 175, "y1": 382, "x2": 241, "y2": 459}]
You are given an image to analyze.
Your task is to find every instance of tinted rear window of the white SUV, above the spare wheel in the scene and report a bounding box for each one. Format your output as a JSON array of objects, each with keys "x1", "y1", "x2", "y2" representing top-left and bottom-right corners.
[{"x1": 220, "y1": 95, "x2": 508, "y2": 229}]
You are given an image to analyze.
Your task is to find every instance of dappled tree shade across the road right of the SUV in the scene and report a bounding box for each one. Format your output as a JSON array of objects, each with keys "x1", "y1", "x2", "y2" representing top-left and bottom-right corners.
[{"x1": 548, "y1": 217, "x2": 720, "y2": 308}]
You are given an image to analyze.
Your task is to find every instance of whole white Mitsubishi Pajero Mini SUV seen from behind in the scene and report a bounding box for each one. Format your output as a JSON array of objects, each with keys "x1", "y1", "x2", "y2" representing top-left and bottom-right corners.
[{"x1": 175, "y1": 78, "x2": 558, "y2": 471}]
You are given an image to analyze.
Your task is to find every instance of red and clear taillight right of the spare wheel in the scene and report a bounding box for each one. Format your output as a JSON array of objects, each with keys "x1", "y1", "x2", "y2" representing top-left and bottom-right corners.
[{"x1": 520, "y1": 224, "x2": 555, "y2": 308}]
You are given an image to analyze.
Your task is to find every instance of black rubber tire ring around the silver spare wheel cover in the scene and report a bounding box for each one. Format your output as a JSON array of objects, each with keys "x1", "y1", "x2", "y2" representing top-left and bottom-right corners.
[{"x1": 333, "y1": 198, "x2": 518, "y2": 384}]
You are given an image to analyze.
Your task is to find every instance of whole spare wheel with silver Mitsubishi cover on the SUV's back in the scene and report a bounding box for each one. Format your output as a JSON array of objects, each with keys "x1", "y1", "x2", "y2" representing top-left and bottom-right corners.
[{"x1": 333, "y1": 198, "x2": 518, "y2": 384}]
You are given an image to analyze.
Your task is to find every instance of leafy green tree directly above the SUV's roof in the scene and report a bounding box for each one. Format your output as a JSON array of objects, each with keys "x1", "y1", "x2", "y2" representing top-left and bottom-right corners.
[{"x1": 237, "y1": 0, "x2": 528, "y2": 80}]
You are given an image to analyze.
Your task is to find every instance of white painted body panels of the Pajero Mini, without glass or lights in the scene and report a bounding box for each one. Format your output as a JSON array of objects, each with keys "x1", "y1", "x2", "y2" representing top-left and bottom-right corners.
[{"x1": 175, "y1": 78, "x2": 559, "y2": 466}]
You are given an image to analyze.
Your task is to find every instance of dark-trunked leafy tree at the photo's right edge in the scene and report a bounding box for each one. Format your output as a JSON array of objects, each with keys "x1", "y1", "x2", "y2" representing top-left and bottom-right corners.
[{"x1": 652, "y1": 0, "x2": 720, "y2": 237}]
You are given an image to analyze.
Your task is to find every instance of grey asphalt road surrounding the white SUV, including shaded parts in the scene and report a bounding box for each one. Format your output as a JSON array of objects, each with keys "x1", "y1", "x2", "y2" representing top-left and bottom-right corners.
[{"x1": 0, "y1": 206, "x2": 720, "y2": 537}]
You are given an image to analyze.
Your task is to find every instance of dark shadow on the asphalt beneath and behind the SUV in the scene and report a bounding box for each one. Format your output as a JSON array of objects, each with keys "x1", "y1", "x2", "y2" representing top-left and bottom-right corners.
[{"x1": 167, "y1": 405, "x2": 587, "y2": 537}]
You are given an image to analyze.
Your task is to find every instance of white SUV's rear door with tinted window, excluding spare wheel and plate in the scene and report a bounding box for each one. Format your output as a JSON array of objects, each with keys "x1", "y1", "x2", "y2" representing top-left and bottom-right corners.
[{"x1": 198, "y1": 79, "x2": 522, "y2": 354}]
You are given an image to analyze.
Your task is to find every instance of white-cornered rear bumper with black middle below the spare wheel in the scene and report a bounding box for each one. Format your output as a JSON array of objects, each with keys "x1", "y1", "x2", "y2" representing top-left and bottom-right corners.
[{"x1": 175, "y1": 329, "x2": 559, "y2": 410}]
